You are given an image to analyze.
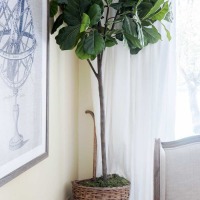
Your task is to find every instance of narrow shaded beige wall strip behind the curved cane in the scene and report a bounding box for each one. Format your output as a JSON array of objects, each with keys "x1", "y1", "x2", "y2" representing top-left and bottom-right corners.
[{"x1": 78, "y1": 61, "x2": 94, "y2": 179}]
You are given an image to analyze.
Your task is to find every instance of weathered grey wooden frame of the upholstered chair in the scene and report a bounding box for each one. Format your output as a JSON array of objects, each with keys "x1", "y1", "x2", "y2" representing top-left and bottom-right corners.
[{"x1": 154, "y1": 135, "x2": 200, "y2": 200}]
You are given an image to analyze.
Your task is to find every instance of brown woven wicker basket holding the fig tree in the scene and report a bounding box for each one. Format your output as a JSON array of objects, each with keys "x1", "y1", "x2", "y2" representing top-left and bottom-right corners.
[{"x1": 72, "y1": 181, "x2": 130, "y2": 200}]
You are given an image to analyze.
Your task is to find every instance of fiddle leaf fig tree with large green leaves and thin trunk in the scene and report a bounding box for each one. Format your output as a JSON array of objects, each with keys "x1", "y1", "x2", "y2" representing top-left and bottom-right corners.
[{"x1": 50, "y1": 0, "x2": 172, "y2": 179}]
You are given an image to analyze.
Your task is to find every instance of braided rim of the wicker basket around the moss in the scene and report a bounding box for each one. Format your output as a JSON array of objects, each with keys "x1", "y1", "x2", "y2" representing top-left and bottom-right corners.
[{"x1": 72, "y1": 179, "x2": 131, "y2": 191}]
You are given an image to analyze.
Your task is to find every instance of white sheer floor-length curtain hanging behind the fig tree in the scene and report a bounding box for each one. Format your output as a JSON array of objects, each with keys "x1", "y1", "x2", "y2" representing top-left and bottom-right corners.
[{"x1": 91, "y1": 4, "x2": 176, "y2": 200}]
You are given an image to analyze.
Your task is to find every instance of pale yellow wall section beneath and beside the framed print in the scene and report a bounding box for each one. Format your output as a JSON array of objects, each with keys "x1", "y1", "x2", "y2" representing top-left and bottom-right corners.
[{"x1": 0, "y1": 38, "x2": 78, "y2": 200}]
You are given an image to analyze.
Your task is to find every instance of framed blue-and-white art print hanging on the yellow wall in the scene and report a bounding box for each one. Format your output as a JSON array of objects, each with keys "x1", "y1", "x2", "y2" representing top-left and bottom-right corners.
[{"x1": 0, "y1": 0, "x2": 48, "y2": 186}]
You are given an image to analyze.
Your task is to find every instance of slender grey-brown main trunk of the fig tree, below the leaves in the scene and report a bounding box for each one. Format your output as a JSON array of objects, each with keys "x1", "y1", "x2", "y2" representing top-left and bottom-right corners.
[{"x1": 97, "y1": 55, "x2": 107, "y2": 180}]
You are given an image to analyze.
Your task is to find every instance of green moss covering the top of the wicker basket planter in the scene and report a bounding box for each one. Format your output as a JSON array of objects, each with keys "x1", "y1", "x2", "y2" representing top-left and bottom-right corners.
[{"x1": 80, "y1": 174, "x2": 130, "y2": 188}]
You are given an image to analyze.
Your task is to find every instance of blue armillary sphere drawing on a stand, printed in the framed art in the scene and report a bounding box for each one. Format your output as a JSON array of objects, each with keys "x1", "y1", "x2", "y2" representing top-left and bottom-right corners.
[{"x1": 0, "y1": 0, "x2": 36, "y2": 150}]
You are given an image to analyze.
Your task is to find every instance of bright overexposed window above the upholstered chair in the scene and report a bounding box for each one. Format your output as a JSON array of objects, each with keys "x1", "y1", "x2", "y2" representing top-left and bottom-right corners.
[{"x1": 175, "y1": 0, "x2": 200, "y2": 139}]
